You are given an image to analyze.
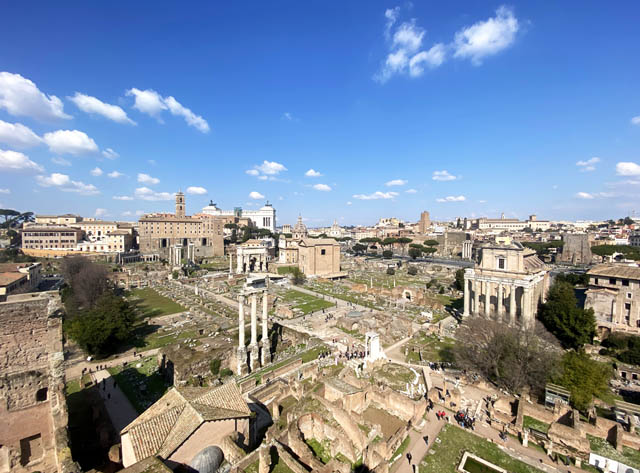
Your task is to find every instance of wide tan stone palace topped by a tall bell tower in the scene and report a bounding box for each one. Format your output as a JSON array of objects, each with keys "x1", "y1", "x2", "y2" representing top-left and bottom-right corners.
[{"x1": 138, "y1": 192, "x2": 224, "y2": 260}]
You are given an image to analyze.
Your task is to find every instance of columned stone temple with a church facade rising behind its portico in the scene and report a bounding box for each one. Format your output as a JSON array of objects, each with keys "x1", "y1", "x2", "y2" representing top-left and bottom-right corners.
[{"x1": 463, "y1": 240, "x2": 549, "y2": 329}]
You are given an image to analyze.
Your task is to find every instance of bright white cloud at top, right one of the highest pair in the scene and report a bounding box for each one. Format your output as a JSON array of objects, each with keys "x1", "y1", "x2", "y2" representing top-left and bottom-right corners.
[{"x1": 453, "y1": 5, "x2": 520, "y2": 65}]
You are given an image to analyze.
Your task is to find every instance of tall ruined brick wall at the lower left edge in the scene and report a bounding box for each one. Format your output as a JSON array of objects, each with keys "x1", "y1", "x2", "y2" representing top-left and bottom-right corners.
[{"x1": 0, "y1": 292, "x2": 74, "y2": 473}]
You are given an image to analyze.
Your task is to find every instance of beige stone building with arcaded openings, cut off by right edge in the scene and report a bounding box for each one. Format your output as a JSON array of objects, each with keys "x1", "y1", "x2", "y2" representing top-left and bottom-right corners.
[{"x1": 585, "y1": 263, "x2": 640, "y2": 335}]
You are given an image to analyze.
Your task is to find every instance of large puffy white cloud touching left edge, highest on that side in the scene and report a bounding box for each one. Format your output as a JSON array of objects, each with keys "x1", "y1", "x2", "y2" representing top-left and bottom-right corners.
[{"x1": 0, "y1": 72, "x2": 71, "y2": 121}]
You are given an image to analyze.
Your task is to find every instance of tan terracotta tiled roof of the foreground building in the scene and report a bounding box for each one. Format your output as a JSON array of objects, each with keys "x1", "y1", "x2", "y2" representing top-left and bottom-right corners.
[{"x1": 121, "y1": 383, "x2": 251, "y2": 460}]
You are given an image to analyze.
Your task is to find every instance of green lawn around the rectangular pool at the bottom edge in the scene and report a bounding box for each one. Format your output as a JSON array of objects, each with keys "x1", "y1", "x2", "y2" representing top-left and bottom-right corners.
[{"x1": 420, "y1": 425, "x2": 542, "y2": 473}]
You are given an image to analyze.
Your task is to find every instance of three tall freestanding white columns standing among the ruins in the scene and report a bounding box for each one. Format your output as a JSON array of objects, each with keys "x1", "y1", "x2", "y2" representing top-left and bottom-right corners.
[{"x1": 237, "y1": 291, "x2": 270, "y2": 375}]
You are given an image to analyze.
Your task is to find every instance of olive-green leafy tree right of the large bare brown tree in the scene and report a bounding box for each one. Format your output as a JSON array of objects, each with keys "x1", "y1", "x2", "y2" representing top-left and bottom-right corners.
[{"x1": 553, "y1": 350, "x2": 612, "y2": 412}]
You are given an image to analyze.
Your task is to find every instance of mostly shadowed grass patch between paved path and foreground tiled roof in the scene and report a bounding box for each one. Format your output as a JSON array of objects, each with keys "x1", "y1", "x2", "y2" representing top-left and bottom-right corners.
[{"x1": 109, "y1": 356, "x2": 167, "y2": 413}]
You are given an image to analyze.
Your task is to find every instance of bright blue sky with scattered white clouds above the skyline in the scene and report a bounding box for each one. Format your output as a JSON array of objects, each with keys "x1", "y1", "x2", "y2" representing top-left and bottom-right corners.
[{"x1": 0, "y1": 1, "x2": 640, "y2": 226}]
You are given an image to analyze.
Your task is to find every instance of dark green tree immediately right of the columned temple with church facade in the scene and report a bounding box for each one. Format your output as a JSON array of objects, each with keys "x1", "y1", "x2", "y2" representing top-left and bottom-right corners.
[{"x1": 538, "y1": 281, "x2": 596, "y2": 349}]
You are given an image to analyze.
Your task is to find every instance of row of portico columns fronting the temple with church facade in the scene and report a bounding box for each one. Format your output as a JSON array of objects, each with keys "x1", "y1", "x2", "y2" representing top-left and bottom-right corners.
[{"x1": 464, "y1": 279, "x2": 535, "y2": 326}]
